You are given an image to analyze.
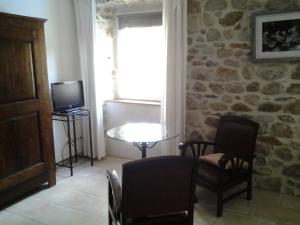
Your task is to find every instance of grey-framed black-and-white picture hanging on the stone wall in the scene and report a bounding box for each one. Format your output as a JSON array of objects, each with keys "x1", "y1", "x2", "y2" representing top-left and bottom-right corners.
[{"x1": 251, "y1": 9, "x2": 300, "y2": 62}]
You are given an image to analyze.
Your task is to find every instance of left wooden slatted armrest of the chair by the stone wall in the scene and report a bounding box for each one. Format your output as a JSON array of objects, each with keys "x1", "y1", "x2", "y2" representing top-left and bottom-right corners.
[{"x1": 178, "y1": 140, "x2": 215, "y2": 158}]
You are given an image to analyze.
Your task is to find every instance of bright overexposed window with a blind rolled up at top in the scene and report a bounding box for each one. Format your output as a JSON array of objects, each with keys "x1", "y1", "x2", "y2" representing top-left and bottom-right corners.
[{"x1": 115, "y1": 13, "x2": 164, "y2": 101}]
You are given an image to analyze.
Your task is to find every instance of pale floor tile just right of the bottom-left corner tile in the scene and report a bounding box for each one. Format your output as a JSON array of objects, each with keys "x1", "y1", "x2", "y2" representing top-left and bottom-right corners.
[{"x1": 6, "y1": 197, "x2": 96, "y2": 225}]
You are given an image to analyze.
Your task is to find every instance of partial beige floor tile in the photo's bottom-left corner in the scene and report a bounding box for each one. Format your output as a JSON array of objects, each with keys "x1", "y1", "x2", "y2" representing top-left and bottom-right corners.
[{"x1": 0, "y1": 211, "x2": 42, "y2": 225}]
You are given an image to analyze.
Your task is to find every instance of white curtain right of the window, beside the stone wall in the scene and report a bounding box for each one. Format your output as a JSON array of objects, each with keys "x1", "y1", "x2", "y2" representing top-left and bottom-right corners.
[{"x1": 161, "y1": 0, "x2": 187, "y2": 155}]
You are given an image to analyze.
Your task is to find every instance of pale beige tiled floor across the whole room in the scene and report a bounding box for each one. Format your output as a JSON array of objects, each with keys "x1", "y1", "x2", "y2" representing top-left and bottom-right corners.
[{"x1": 0, "y1": 157, "x2": 300, "y2": 225}]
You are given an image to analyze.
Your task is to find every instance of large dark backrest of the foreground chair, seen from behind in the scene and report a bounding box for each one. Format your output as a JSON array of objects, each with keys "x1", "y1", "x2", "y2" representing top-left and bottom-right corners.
[{"x1": 121, "y1": 156, "x2": 196, "y2": 218}]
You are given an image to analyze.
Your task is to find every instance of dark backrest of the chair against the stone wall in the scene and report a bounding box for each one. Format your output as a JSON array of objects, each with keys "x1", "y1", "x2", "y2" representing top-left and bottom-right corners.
[{"x1": 215, "y1": 115, "x2": 259, "y2": 153}]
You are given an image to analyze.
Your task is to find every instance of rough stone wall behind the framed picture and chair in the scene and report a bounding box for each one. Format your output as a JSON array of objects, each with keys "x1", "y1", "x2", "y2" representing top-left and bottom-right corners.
[{"x1": 186, "y1": 0, "x2": 300, "y2": 195}]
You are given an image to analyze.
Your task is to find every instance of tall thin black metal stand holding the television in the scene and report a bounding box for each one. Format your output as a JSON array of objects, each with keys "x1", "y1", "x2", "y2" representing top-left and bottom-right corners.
[{"x1": 52, "y1": 108, "x2": 94, "y2": 176}]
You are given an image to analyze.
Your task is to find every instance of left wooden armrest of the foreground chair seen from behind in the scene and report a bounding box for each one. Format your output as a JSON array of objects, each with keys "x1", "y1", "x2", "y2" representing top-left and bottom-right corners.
[{"x1": 106, "y1": 170, "x2": 122, "y2": 212}]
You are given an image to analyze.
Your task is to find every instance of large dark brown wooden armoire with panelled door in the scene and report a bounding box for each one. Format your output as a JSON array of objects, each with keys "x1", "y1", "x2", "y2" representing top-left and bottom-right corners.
[{"x1": 0, "y1": 13, "x2": 56, "y2": 205}]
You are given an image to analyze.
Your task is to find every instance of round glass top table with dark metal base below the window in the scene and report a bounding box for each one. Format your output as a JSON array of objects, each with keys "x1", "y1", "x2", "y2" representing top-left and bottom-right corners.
[{"x1": 107, "y1": 123, "x2": 179, "y2": 158}]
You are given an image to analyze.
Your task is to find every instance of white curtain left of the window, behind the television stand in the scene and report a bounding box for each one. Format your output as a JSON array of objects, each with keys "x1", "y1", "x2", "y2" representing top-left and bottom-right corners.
[{"x1": 73, "y1": 0, "x2": 105, "y2": 159}]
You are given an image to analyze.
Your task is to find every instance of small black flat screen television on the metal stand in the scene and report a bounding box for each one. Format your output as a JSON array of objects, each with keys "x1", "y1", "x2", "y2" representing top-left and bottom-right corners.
[{"x1": 51, "y1": 80, "x2": 84, "y2": 112}]
